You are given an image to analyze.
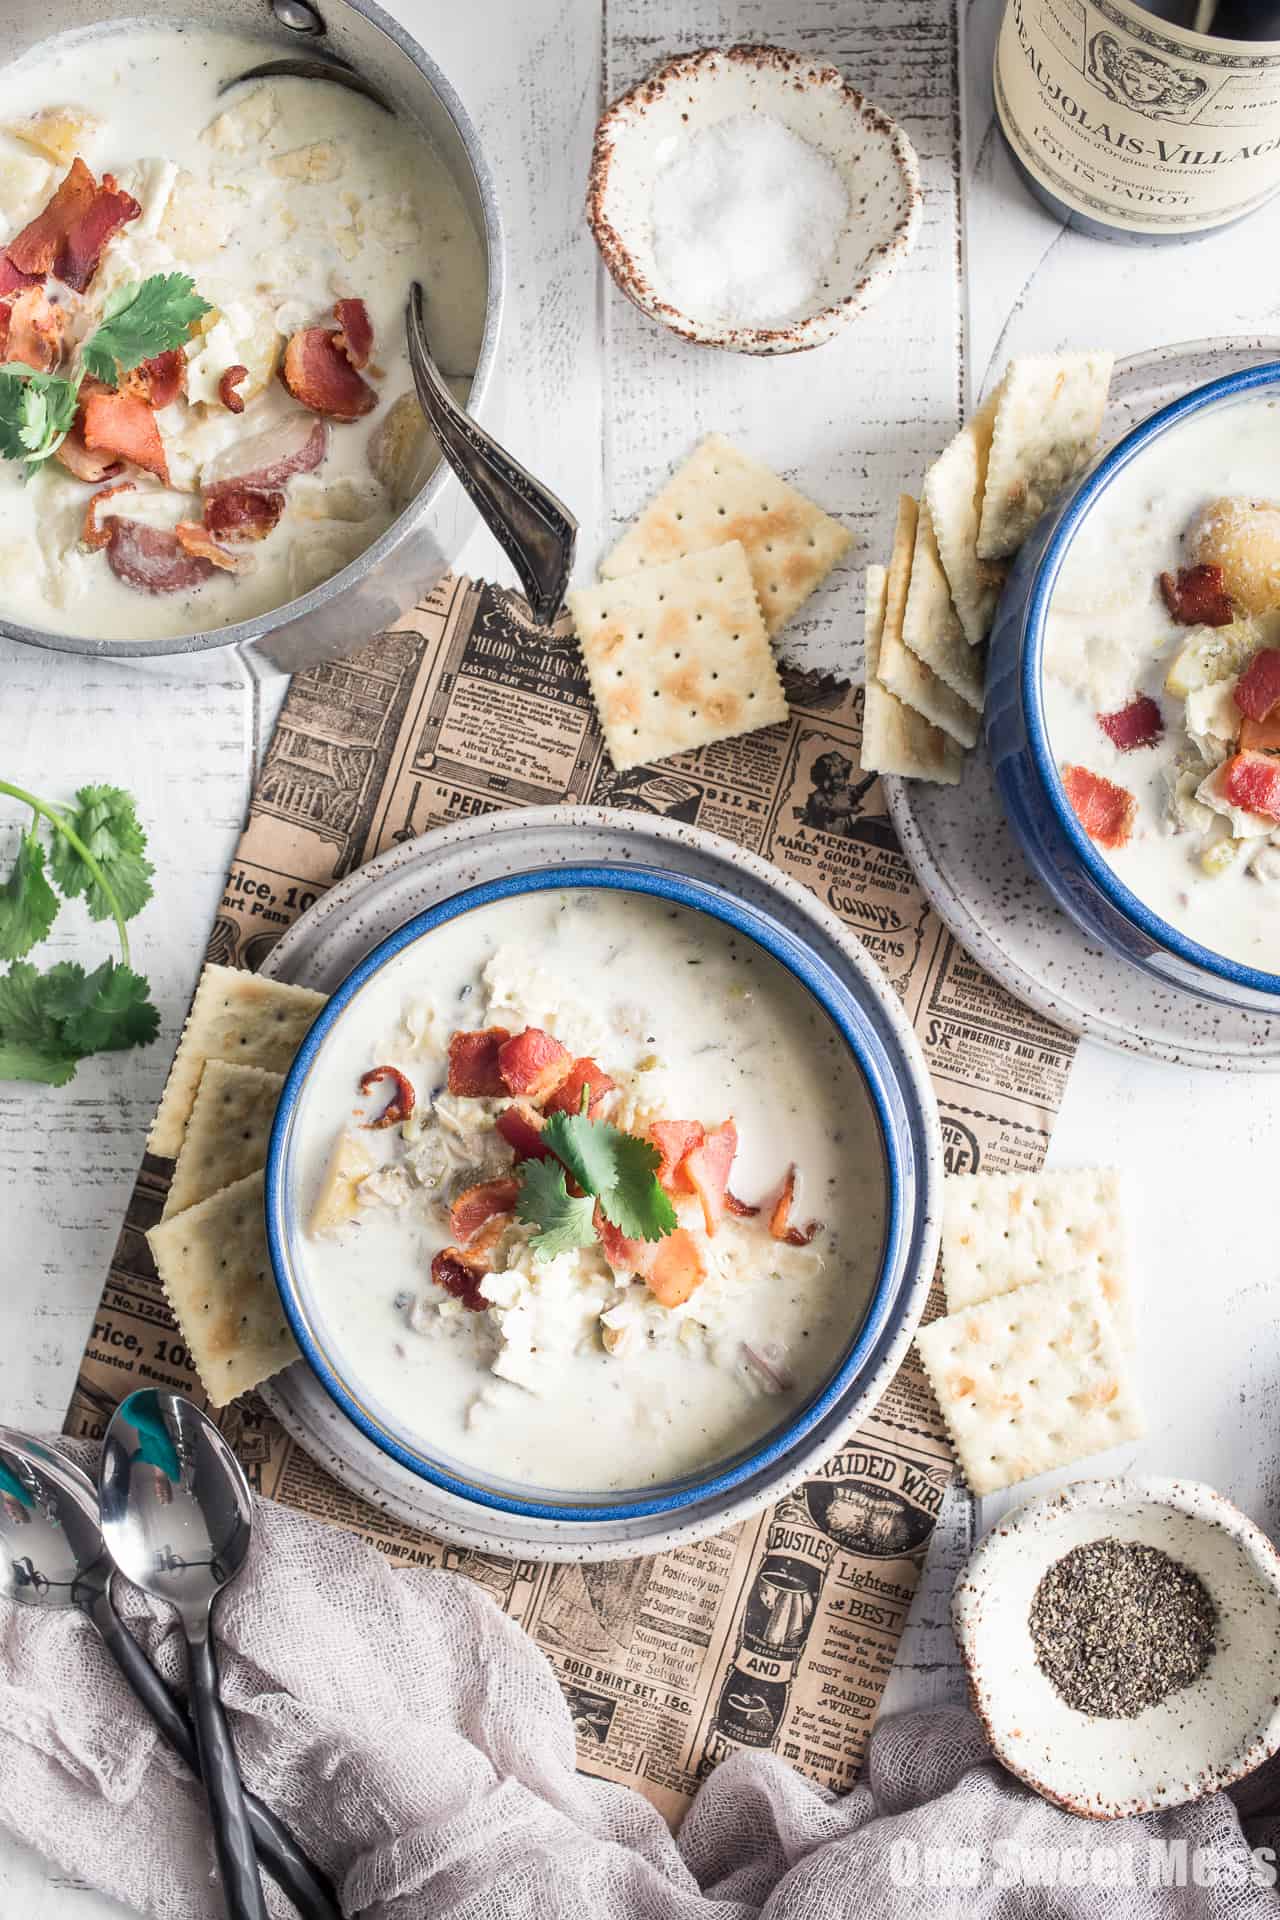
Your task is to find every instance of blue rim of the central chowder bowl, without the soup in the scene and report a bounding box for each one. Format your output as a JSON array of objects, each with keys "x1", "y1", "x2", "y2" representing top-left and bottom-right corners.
[{"x1": 267, "y1": 866, "x2": 904, "y2": 1524}]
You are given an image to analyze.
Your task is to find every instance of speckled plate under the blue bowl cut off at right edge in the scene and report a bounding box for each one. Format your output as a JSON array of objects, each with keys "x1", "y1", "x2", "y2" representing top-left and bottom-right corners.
[{"x1": 885, "y1": 336, "x2": 1280, "y2": 1073}]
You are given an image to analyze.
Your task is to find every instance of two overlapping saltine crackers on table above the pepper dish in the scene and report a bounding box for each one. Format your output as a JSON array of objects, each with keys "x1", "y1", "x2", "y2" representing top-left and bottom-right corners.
[{"x1": 915, "y1": 1169, "x2": 1142, "y2": 1494}]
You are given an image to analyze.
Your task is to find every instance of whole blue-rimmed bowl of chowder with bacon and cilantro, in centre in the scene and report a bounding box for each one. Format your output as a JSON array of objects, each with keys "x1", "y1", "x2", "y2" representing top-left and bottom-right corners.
[{"x1": 267, "y1": 862, "x2": 931, "y2": 1528}]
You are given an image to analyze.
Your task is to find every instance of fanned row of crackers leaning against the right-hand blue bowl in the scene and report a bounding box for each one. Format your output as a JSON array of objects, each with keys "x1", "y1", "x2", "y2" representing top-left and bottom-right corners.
[{"x1": 862, "y1": 353, "x2": 1113, "y2": 785}]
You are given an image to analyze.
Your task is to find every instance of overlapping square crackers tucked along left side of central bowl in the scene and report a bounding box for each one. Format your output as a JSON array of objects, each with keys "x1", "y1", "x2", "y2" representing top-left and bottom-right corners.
[{"x1": 146, "y1": 966, "x2": 324, "y2": 1407}]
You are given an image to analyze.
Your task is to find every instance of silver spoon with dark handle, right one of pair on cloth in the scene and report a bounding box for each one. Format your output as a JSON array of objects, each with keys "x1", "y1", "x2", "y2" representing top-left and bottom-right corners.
[{"x1": 98, "y1": 1388, "x2": 267, "y2": 1920}]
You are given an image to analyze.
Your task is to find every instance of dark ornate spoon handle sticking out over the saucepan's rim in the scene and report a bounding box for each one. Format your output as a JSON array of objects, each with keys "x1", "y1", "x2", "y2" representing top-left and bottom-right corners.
[{"x1": 405, "y1": 280, "x2": 578, "y2": 626}]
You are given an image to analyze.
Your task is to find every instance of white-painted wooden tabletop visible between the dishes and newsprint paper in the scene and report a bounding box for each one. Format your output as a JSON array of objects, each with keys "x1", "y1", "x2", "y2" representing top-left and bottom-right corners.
[{"x1": 0, "y1": 0, "x2": 1280, "y2": 1896}]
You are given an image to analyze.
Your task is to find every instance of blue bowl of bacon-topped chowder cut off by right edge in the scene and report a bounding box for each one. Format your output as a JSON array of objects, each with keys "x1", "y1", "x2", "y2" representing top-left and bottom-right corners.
[{"x1": 986, "y1": 363, "x2": 1280, "y2": 1014}]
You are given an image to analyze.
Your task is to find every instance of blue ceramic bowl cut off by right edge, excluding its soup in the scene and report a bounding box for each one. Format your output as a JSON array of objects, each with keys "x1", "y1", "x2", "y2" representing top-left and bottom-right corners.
[{"x1": 986, "y1": 361, "x2": 1280, "y2": 1014}]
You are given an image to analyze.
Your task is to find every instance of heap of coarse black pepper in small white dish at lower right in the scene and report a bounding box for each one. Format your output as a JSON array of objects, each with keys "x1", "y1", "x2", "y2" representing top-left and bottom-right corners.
[{"x1": 1029, "y1": 1538, "x2": 1219, "y2": 1720}]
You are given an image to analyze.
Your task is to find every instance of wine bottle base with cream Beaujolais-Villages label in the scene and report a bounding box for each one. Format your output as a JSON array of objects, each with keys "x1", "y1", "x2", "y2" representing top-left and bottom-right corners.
[{"x1": 996, "y1": 0, "x2": 1280, "y2": 234}]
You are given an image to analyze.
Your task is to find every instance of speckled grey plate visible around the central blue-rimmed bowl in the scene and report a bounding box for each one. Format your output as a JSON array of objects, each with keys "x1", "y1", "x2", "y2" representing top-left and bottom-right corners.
[{"x1": 261, "y1": 806, "x2": 942, "y2": 1561}]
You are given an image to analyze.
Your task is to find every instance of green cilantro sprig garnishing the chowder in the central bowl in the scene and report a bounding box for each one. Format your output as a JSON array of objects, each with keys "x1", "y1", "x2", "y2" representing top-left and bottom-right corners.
[{"x1": 516, "y1": 1089, "x2": 676, "y2": 1260}]
